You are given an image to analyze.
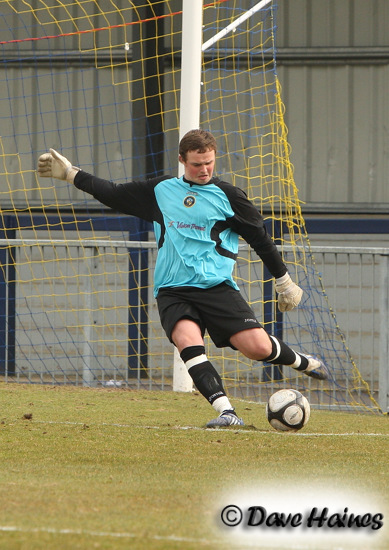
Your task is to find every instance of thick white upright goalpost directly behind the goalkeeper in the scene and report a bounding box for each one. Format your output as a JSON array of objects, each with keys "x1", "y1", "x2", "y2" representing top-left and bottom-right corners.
[{"x1": 173, "y1": 0, "x2": 203, "y2": 392}]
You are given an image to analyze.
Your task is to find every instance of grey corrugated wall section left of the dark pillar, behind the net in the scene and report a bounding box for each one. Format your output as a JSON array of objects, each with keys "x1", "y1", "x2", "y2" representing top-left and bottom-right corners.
[{"x1": 0, "y1": 0, "x2": 137, "y2": 208}]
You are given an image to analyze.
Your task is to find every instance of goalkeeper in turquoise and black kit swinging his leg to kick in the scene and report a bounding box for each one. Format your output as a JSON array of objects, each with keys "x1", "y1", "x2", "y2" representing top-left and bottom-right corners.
[{"x1": 38, "y1": 130, "x2": 328, "y2": 427}]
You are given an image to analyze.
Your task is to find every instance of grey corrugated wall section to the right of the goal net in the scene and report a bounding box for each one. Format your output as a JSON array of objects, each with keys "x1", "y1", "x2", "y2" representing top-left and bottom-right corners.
[{"x1": 277, "y1": 0, "x2": 389, "y2": 211}]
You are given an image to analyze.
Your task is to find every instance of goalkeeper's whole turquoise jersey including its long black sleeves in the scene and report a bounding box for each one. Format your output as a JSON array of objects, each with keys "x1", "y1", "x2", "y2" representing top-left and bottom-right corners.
[{"x1": 74, "y1": 171, "x2": 287, "y2": 295}]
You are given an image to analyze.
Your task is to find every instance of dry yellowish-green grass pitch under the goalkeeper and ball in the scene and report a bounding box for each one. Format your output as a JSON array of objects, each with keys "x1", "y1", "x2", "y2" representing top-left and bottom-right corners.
[{"x1": 0, "y1": 383, "x2": 389, "y2": 550}]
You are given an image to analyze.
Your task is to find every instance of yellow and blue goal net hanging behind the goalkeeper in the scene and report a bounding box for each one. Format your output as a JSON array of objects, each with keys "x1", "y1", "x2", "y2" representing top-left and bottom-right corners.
[{"x1": 0, "y1": 0, "x2": 379, "y2": 411}]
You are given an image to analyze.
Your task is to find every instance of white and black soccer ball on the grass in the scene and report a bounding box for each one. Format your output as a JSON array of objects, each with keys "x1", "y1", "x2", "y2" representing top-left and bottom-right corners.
[{"x1": 266, "y1": 390, "x2": 311, "y2": 432}]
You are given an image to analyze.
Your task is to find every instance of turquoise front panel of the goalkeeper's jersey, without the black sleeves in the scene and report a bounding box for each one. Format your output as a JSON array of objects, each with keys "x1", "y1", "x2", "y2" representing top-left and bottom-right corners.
[{"x1": 154, "y1": 178, "x2": 239, "y2": 296}]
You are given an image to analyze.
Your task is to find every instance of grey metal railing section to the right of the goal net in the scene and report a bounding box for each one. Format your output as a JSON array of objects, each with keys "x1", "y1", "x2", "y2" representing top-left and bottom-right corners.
[{"x1": 304, "y1": 246, "x2": 389, "y2": 411}]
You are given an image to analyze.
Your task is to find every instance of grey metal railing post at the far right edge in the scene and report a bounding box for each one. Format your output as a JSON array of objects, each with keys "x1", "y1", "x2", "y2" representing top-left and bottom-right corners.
[{"x1": 378, "y1": 255, "x2": 389, "y2": 413}]
